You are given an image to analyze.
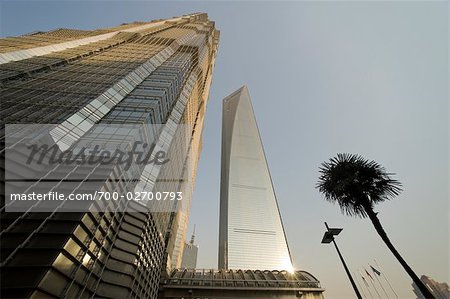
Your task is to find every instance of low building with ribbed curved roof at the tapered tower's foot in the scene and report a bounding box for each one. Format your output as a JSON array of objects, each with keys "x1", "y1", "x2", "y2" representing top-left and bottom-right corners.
[{"x1": 160, "y1": 269, "x2": 324, "y2": 299}]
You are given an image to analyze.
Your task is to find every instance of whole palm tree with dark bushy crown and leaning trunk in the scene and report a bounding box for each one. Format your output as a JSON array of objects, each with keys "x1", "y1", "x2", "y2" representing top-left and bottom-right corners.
[{"x1": 316, "y1": 154, "x2": 434, "y2": 298}]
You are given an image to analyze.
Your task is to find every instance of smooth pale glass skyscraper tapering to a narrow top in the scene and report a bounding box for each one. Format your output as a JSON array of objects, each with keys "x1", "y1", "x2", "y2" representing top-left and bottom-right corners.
[{"x1": 219, "y1": 86, "x2": 293, "y2": 271}]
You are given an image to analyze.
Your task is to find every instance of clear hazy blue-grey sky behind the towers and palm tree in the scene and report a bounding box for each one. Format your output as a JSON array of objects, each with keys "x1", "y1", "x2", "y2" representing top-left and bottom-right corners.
[{"x1": 0, "y1": 1, "x2": 450, "y2": 299}]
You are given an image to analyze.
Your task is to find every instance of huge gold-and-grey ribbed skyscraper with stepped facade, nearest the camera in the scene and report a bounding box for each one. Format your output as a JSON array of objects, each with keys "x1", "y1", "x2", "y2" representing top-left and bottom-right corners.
[{"x1": 0, "y1": 13, "x2": 219, "y2": 298}]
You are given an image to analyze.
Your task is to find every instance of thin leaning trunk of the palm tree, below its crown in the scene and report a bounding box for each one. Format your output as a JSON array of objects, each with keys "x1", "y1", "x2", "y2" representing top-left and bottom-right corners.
[{"x1": 365, "y1": 207, "x2": 435, "y2": 299}]
